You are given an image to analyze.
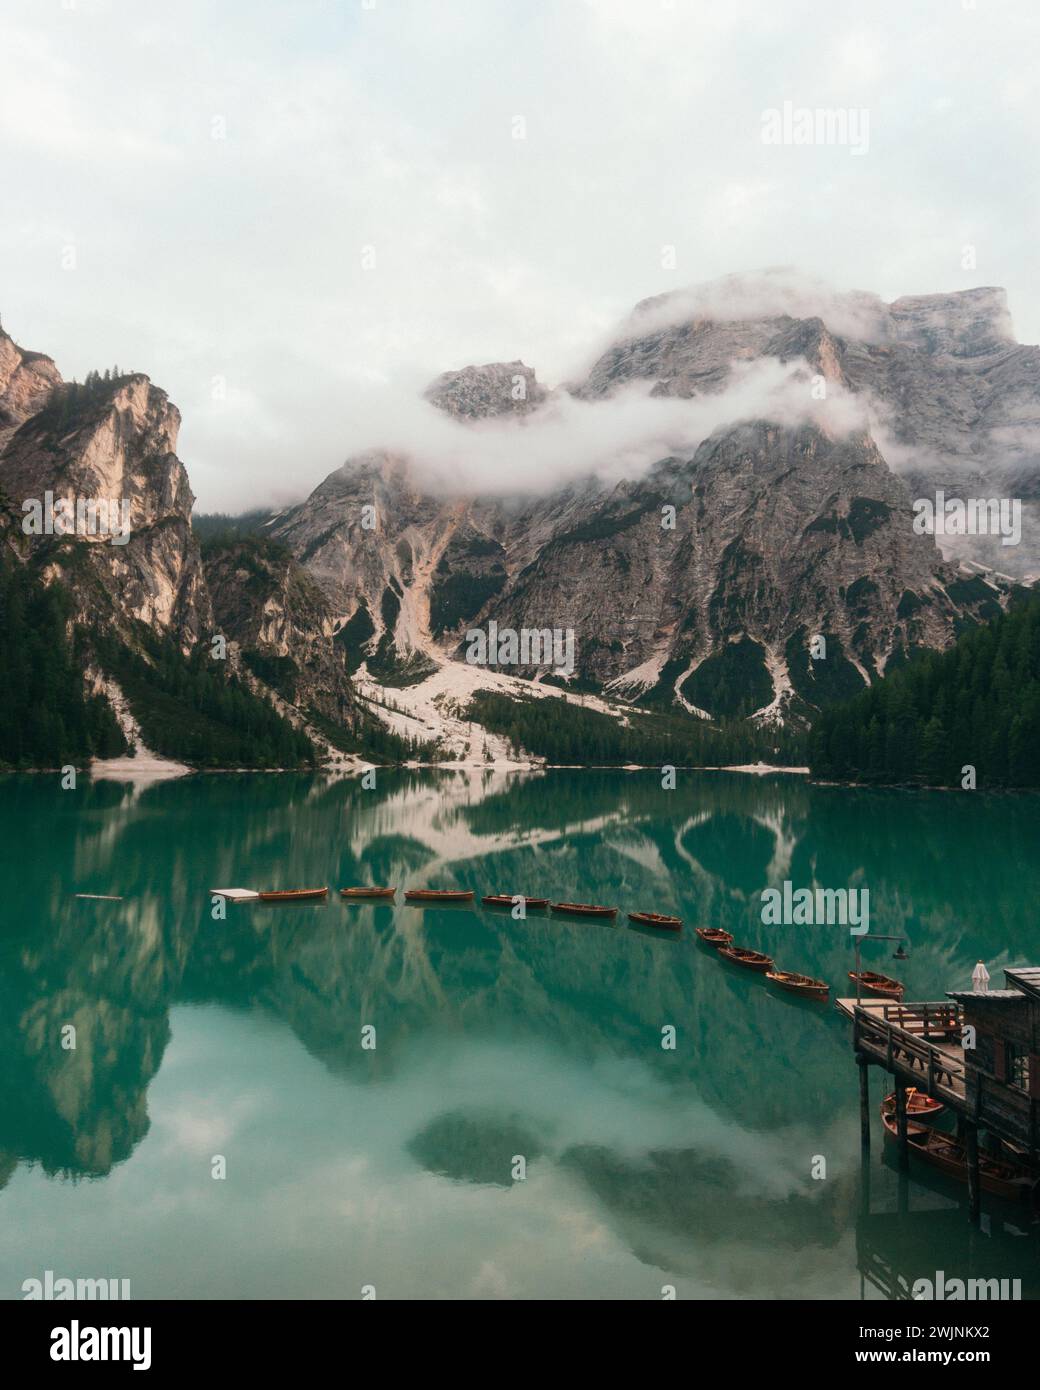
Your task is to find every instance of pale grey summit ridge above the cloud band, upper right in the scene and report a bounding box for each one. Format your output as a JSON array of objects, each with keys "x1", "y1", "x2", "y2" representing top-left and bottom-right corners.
[{"x1": 576, "y1": 279, "x2": 1040, "y2": 577}]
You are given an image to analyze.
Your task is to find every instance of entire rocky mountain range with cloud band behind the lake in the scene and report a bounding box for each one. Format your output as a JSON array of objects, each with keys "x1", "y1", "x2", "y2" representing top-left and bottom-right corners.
[{"x1": 0, "y1": 272, "x2": 1040, "y2": 766}]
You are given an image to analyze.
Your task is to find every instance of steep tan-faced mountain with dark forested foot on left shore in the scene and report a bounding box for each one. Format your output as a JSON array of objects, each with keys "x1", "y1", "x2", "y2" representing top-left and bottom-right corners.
[{"x1": 0, "y1": 332, "x2": 361, "y2": 766}]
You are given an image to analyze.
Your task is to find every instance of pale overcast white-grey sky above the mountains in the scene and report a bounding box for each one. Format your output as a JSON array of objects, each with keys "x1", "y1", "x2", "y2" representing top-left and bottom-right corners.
[{"x1": 0, "y1": 0, "x2": 1040, "y2": 510}]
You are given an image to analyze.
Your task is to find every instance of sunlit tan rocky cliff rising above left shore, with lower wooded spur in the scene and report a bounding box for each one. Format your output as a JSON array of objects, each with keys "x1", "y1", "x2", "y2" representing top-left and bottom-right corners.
[{"x1": 0, "y1": 334, "x2": 359, "y2": 766}]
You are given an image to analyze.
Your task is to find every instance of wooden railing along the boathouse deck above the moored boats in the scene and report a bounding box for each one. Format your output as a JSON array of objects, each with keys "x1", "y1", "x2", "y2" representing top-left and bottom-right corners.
[{"x1": 852, "y1": 1001, "x2": 965, "y2": 1102}]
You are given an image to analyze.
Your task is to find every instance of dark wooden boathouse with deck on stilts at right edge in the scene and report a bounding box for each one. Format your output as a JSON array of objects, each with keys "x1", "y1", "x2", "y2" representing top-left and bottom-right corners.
[{"x1": 838, "y1": 966, "x2": 1040, "y2": 1220}]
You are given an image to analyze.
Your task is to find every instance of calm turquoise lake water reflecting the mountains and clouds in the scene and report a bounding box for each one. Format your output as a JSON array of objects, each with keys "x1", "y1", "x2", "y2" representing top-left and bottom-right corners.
[{"x1": 0, "y1": 771, "x2": 1040, "y2": 1298}]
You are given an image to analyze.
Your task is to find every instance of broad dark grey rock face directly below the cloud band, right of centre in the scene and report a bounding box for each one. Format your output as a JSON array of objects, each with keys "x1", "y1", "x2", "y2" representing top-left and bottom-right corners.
[{"x1": 499, "y1": 421, "x2": 959, "y2": 714}]
